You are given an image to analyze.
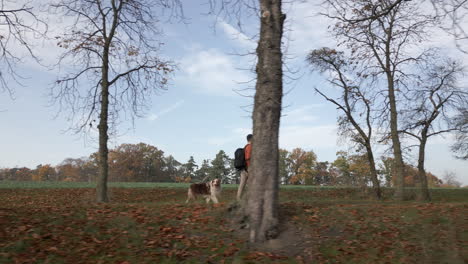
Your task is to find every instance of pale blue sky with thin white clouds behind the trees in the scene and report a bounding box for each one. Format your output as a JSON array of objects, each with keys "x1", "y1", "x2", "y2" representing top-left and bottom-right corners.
[{"x1": 0, "y1": 1, "x2": 468, "y2": 185}]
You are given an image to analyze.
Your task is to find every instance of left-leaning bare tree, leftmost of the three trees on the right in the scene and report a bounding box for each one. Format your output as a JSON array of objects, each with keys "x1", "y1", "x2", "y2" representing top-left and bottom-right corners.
[{"x1": 307, "y1": 48, "x2": 382, "y2": 199}]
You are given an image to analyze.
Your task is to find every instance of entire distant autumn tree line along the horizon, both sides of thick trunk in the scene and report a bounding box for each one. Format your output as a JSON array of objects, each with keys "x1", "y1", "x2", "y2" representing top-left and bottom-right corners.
[{"x1": 0, "y1": 143, "x2": 460, "y2": 187}]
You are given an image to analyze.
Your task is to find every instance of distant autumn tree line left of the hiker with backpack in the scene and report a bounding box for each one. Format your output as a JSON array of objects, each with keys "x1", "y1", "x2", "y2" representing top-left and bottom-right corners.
[{"x1": 0, "y1": 143, "x2": 237, "y2": 183}]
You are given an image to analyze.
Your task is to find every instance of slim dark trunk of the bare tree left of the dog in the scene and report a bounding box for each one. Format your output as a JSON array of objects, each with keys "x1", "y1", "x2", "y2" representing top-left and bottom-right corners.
[{"x1": 96, "y1": 54, "x2": 109, "y2": 203}]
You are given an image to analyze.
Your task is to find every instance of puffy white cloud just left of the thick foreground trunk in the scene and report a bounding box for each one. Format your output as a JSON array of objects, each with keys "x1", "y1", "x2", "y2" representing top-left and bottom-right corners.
[{"x1": 179, "y1": 49, "x2": 251, "y2": 96}]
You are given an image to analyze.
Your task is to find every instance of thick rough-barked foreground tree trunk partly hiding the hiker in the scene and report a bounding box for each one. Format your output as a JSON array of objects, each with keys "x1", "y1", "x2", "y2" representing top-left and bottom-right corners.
[{"x1": 247, "y1": 0, "x2": 286, "y2": 242}]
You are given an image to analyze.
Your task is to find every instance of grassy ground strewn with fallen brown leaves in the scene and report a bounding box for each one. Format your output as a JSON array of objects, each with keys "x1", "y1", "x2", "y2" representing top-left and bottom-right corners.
[{"x1": 0, "y1": 182, "x2": 468, "y2": 264}]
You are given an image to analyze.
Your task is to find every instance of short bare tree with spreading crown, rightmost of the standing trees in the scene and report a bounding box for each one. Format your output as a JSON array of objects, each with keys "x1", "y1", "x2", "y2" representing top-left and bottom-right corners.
[{"x1": 402, "y1": 56, "x2": 468, "y2": 201}]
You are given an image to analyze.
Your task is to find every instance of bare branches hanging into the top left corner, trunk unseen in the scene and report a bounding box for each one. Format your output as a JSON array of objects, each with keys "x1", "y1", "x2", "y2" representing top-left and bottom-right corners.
[{"x1": 0, "y1": 0, "x2": 47, "y2": 96}]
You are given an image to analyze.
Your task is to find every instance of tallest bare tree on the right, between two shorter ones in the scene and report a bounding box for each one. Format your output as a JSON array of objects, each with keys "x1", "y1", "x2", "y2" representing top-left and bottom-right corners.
[{"x1": 326, "y1": 0, "x2": 434, "y2": 200}]
